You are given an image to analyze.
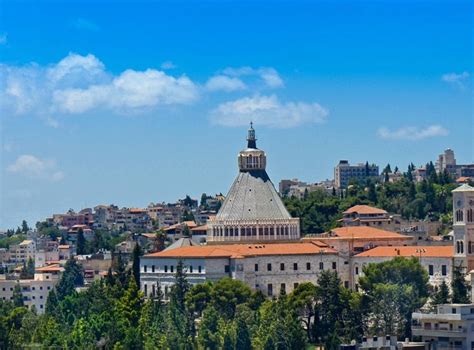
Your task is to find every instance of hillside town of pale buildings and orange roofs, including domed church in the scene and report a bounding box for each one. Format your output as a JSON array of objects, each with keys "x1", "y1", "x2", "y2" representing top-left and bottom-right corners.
[{"x1": 0, "y1": 125, "x2": 474, "y2": 349}]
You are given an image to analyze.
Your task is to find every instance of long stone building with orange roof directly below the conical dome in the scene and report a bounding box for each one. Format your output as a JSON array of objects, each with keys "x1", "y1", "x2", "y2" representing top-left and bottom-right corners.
[{"x1": 140, "y1": 242, "x2": 343, "y2": 298}]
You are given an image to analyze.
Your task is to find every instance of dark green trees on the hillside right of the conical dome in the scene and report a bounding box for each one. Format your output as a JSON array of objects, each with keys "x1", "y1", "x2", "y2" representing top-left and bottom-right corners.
[{"x1": 283, "y1": 163, "x2": 457, "y2": 234}]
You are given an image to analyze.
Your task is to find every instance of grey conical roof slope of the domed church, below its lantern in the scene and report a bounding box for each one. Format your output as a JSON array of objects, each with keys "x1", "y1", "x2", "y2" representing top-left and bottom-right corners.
[{"x1": 216, "y1": 170, "x2": 291, "y2": 220}]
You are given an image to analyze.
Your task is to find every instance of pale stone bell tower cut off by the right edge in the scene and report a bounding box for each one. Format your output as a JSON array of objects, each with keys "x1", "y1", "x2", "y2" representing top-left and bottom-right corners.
[{"x1": 453, "y1": 184, "x2": 474, "y2": 273}]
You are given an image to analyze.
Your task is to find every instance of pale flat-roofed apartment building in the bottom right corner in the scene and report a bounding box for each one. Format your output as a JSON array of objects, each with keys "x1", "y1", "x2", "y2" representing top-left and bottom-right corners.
[{"x1": 411, "y1": 304, "x2": 474, "y2": 350}]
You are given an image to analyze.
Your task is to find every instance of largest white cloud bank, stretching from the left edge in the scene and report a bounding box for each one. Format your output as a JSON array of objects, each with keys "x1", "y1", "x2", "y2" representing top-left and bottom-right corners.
[{"x1": 0, "y1": 53, "x2": 199, "y2": 117}]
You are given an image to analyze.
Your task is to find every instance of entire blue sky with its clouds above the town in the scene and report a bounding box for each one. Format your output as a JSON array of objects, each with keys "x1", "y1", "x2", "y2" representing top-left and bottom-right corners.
[{"x1": 0, "y1": 1, "x2": 474, "y2": 228}]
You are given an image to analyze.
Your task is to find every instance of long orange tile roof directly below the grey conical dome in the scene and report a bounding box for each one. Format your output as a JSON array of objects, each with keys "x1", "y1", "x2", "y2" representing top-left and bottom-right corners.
[{"x1": 144, "y1": 242, "x2": 337, "y2": 258}]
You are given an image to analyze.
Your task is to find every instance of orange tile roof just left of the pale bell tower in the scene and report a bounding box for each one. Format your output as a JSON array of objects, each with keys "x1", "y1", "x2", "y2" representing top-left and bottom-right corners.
[{"x1": 356, "y1": 246, "x2": 454, "y2": 258}]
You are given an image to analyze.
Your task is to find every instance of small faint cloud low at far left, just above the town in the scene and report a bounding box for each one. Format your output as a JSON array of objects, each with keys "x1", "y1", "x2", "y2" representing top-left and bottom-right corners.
[{"x1": 7, "y1": 154, "x2": 64, "y2": 181}]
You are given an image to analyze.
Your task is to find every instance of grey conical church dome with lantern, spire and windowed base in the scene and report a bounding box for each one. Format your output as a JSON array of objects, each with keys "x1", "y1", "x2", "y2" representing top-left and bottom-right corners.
[{"x1": 207, "y1": 123, "x2": 300, "y2": 244}]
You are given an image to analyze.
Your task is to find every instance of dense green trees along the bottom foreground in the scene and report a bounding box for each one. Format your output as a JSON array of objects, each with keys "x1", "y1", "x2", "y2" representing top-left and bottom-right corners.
[{"x1": 0, "y1": 256, "x2": 444, "y2": 350}]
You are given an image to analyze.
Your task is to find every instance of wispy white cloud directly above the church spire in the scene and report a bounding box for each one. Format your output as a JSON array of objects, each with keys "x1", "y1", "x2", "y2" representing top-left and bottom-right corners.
[{"x1": 211, "y1": 95, "x2": 329, "y2": 128}]
